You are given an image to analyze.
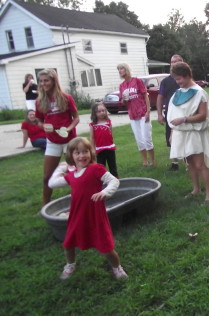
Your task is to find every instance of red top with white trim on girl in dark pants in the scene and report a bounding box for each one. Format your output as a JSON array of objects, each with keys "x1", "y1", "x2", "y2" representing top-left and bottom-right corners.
[{"x1": 89, "y1": 120, "x2": 116, "y2": 154}]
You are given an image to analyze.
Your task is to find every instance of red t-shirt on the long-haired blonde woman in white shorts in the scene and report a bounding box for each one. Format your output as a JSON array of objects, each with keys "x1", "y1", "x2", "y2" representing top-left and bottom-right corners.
[{"x1": 36, "y1": 94, "x2": 77, "y2": 144}]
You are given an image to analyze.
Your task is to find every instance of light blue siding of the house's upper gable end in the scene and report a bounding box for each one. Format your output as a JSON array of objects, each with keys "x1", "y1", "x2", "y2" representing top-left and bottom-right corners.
[{"x1": 0, "y1": 6, "x2": 54, "y2": 54}]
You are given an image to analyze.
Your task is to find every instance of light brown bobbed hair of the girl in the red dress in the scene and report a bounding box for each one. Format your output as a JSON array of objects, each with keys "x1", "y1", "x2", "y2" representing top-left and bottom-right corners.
[{"x1": 65, "y1": 137, "x2": 96, "y2": 166}]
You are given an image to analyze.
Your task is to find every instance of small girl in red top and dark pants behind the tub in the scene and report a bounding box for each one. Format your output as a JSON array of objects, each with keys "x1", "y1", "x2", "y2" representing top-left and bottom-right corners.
[{"x1": 89, "y1": 103, "x2": 118, "y2": 178}]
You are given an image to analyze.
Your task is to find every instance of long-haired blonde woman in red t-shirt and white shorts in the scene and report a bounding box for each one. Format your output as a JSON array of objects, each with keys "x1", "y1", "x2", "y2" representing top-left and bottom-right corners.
[{"x1": 36, "y1": 69, "x2": 79, "y2": 204}]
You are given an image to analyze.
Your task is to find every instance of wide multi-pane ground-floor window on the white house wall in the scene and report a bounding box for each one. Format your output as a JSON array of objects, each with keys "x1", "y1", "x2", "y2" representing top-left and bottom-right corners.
[{"x1": 81, "y1": 69, "x2": 102, "y2": 87}]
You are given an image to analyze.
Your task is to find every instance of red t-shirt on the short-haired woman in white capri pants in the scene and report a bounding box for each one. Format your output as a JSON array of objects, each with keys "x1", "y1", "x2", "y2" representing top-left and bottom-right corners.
[{"x1": 120, "y1": 78, "x2": 147, "y2": 120}]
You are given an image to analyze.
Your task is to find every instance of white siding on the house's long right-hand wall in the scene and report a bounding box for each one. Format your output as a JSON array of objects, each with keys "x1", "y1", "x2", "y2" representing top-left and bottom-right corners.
[{"x1": 53, "y1": 31, "x2": 149, "y2": 99}]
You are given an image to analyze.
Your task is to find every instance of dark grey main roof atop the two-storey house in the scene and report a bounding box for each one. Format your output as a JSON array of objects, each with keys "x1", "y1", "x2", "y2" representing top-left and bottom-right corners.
[{"x1": 10, "y1": 0, "x2": 149, "y2": 37}]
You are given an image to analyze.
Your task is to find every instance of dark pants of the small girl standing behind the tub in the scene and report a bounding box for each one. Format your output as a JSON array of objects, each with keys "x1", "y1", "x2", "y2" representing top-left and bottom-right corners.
[{"x1": 97, "y1": 149, "x2": 118, "y2": 178}]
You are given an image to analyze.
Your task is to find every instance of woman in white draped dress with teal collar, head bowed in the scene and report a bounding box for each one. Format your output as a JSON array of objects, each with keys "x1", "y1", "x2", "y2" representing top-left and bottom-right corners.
[{"x1": 167, "y1": 62, "x2": 209, "y2": 204}]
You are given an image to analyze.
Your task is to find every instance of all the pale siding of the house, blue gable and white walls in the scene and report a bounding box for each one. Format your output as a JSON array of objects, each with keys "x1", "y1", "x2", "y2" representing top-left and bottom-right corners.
[{"x1": 0, "y1": 1, "x2": 148, "y2": 108}]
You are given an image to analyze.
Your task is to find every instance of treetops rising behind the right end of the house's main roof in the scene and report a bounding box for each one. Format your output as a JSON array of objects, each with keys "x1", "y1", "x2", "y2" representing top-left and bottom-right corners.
[{"x1": 94, "y1": 0, "x2": 142, "y2": 28}]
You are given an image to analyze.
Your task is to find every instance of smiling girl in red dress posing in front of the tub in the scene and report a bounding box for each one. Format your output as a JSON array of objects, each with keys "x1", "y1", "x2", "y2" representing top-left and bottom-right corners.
[{"x1": 49, "y1": 137, "x2": 127, "y2": 279}]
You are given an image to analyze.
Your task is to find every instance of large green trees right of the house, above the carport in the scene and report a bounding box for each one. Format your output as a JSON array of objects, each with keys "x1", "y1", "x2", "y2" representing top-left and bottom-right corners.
[{"x1": 147, "y1": 3, "x2": 209, "y2": 80}]
